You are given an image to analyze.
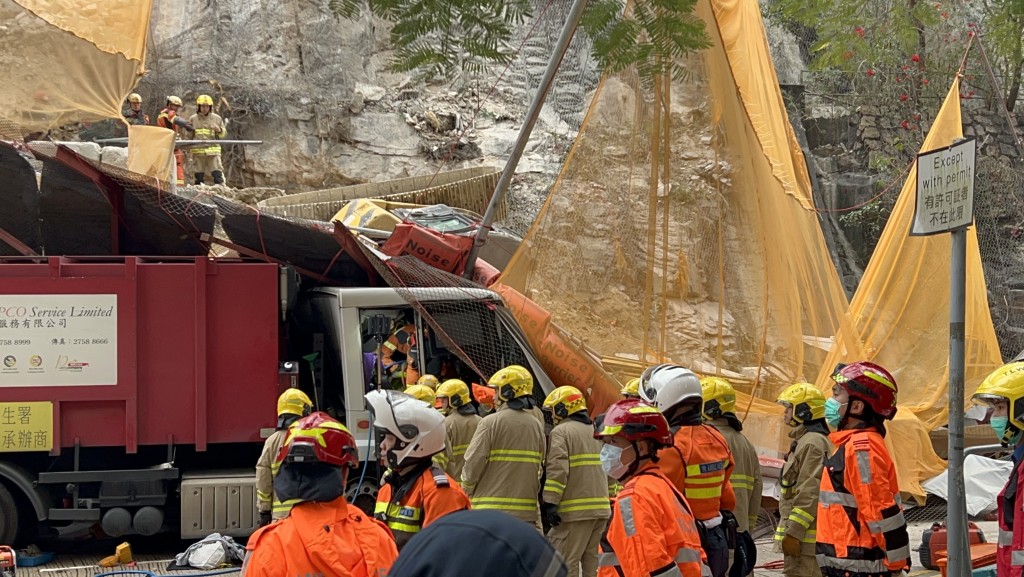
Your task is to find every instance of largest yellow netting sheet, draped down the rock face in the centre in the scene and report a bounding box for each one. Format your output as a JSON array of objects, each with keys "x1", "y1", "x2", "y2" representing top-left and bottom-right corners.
[{"x1": 501, "y1": 0, "x2": 847, "y2": 457}]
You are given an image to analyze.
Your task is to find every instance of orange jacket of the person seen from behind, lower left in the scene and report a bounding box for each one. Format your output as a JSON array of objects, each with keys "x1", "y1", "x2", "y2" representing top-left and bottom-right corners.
[{"x1": 242, "y1": 497, "x2": 398, "y2": 577}]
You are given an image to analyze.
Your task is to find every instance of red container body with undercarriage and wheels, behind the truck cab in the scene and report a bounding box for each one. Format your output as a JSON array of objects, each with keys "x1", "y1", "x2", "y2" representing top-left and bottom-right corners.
[{"x1": 0, "y1": 257, "x2": 281, "y2": 543}]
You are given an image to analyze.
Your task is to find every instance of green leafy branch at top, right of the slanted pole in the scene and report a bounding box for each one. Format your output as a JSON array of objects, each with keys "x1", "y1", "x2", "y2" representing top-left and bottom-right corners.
[{"x1": 582, "y1": 0, "x2": 711, "y2": 86}]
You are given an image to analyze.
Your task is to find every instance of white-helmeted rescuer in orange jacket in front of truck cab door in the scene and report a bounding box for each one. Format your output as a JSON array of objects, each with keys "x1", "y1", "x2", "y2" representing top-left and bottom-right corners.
[{"x1": 366, "y1": 390, "x2": 470, "y2": 550}]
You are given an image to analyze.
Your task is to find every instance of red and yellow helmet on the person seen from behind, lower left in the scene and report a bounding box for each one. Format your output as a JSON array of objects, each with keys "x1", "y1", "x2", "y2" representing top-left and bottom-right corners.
[{"x1": 278, "y1": 411, "x2": 359, "y2": 468}]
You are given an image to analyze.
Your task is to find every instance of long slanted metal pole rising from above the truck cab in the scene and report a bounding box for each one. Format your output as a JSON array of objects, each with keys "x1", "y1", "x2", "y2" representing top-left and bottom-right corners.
[{"x1": 463, "y1": 0, "x2": 587, "y2": 279}]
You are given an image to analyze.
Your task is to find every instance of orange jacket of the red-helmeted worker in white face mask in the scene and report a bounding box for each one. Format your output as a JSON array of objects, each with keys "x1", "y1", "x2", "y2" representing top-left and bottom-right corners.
[{"x1": 597, "y1": 461, "x2": 711, "y2": 577}]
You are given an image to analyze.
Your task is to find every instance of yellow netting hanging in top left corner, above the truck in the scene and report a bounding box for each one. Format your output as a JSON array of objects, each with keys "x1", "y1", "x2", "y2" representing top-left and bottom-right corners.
[{"x1": 0, "y1": 0, "x2": 153, "y2": 136}]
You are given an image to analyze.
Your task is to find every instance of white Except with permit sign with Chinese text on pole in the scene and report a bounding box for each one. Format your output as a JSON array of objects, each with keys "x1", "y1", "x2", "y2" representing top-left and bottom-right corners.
[{"x1": 910, "y1": 138, "x2": 975, "y2": 235}]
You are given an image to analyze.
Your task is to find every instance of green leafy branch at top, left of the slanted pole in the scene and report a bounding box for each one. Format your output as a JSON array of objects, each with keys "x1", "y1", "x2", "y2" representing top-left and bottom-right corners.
[{"x1": 329, "y1": 0, "x2": 530, "y2": 79}]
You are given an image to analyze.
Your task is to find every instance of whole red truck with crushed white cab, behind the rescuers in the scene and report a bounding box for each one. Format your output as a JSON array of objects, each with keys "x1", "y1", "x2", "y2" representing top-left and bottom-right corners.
[{"x1": 0, "y1": 257, "x2": 551, "y2": 542}]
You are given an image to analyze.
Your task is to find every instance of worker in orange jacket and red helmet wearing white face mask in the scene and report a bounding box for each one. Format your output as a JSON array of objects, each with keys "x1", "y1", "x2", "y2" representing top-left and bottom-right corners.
[{"x1": 594, "y1": 399, "x2": 711, "y2": 577}]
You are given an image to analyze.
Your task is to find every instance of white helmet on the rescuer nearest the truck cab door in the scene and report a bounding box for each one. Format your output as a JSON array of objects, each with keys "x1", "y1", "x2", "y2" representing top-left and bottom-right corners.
[{"x1": 366, "y1": 390, "x2": 445, "y2": 467}]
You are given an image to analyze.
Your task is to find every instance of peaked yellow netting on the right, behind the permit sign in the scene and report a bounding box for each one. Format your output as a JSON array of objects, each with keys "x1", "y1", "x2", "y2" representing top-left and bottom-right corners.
[{"x1": 819, "y1": 80, "x2": 1002, "y2": 430}]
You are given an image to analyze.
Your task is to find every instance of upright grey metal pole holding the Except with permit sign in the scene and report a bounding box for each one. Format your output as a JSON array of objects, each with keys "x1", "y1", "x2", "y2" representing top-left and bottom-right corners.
[{"x1": 946, "y1": 226, "x2": 972, "y2": 577}]
